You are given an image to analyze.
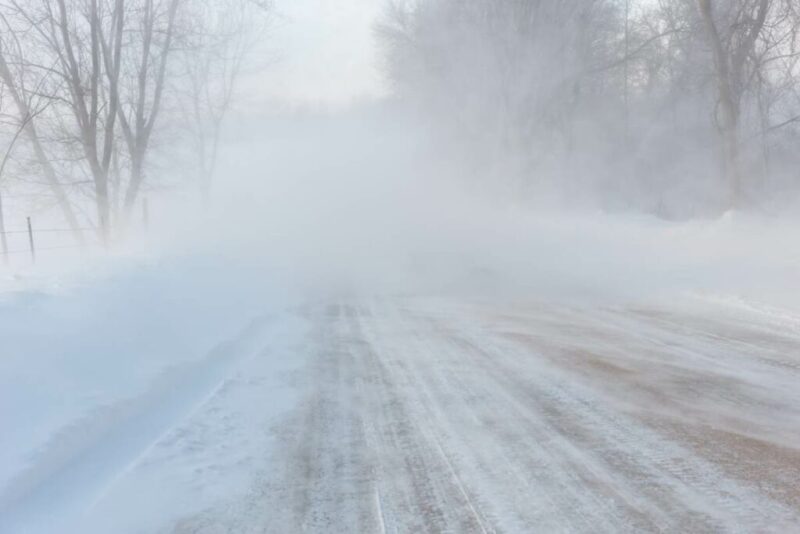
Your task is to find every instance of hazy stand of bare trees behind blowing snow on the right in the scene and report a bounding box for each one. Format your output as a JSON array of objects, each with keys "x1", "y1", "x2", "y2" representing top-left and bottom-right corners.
[{"x1": 380, "y1": 0, "x2": 800, "y2": 217}]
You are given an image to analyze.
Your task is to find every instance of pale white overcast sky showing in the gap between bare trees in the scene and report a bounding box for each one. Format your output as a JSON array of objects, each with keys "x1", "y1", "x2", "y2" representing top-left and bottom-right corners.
[{"x1": 244, "y1": 0, "x2": 386, "y2": 107}]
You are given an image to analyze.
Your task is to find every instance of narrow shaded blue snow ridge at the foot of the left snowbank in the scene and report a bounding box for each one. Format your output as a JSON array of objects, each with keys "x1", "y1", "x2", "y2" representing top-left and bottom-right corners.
[{"x1": 0, "y1": 317, "x2": 282, "y2": 532}]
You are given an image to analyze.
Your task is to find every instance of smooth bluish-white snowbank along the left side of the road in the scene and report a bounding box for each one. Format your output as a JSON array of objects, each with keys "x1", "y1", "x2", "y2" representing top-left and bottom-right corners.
[{"x1": 0, "y1": 256, "x2": 294, "y2": 532}]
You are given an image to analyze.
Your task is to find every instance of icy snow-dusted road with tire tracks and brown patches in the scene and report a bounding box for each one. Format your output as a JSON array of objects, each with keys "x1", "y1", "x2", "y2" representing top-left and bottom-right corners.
[{"x1": 4, "y1": 298, "x2": 800, "y2": 533}]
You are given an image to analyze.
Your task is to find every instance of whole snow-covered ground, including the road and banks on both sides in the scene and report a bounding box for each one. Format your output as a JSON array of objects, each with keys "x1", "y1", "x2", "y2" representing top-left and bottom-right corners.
[{"x1": 0, "y1": 204, "x2": 800, "y2": 534}]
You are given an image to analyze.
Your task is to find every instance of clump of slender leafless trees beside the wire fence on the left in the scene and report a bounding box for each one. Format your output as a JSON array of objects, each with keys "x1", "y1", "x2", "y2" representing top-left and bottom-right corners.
[{"x1": 0, "y1": 0, "x2": 271, "y2": 242}]
